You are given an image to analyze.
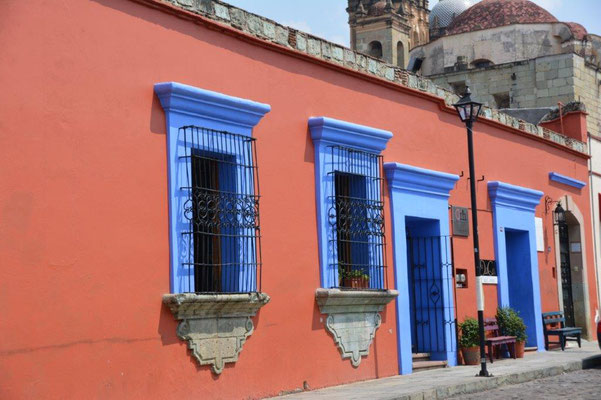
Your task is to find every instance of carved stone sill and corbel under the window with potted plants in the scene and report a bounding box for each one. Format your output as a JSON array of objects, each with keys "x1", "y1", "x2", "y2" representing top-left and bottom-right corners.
[{"x1": 315, "y1": 289, "x2": 399, "y2": 367}]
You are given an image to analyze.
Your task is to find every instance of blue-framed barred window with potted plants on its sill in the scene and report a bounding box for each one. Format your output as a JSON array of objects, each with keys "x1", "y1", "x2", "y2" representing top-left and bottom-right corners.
[{"x1": 309, "y1": 117, "x2": 392, "y2": 289}]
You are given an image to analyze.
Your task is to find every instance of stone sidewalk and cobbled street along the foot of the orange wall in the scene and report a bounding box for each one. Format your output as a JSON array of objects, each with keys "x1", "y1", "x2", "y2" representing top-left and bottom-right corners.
[{"x1": 274, "y1": 341, "x2": 601, "y2": 400}]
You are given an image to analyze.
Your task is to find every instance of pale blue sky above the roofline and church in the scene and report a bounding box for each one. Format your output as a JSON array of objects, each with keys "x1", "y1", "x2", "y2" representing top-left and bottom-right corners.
[{"x1": 225, "y1": 0, "x2": 601, "y2": 46}]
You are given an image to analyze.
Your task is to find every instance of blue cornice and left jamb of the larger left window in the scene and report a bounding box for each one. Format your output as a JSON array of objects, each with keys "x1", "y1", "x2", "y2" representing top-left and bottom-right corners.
[{"x1": 154, "y1": 82, "x2": 271, "y2": 293}]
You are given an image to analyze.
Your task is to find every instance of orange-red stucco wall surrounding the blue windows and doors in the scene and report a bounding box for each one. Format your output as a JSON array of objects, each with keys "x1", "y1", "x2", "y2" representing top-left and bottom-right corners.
[{"x1": 0, "y1": 0, "x2": 596, "y2": 399}]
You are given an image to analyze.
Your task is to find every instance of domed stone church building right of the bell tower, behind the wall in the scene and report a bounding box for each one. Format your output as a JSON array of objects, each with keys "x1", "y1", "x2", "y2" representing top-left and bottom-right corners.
[{"x1": 409, "y1": 0, "x2": 601, "y2": 135}]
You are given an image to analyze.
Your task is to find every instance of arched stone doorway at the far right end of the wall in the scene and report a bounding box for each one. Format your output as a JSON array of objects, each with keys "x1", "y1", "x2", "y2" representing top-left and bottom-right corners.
[{"x1": 554, "y1": 195, "x2": 591, "y2": 338}]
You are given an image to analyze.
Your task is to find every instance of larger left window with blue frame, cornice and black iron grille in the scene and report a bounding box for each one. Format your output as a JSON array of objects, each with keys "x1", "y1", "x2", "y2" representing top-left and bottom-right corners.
[{"x1": 154, "y1": 82, "x2": 270, "y2": 293}]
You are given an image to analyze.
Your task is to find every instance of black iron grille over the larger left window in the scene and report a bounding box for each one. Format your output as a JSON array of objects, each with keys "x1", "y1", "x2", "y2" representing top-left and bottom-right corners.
[{"x1": 179, "y1": 126, "x2": 262, "y2": 293}]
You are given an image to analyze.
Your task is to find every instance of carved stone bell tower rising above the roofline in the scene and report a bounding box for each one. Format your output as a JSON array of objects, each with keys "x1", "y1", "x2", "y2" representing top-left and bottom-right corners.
[{"x1": 346, "y1": 0, "x2": 430, "y2": 68}]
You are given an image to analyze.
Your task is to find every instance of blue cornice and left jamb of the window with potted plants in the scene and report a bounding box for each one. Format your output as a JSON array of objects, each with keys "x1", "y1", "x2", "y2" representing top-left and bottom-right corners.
[{"x1": 309, "y1": 117, "x2": 392, "y2": 288}]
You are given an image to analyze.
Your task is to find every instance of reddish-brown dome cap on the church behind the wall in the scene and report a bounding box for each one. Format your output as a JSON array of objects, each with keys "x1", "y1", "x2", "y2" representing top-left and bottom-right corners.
[{"x1": 443, "y1": 0, "x2": 558, "y2": 35}]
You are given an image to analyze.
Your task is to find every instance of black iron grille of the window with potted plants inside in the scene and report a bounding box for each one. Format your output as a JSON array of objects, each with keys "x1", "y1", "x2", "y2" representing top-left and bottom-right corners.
[{"x1": 326, "y1": 146, "x2": 388, "y2": 290}]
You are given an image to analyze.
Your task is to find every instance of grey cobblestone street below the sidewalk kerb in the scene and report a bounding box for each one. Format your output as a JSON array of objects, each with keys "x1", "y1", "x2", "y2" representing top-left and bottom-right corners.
[{"x1": 451, "y1": 368, "x2": 601, "y2": 400}]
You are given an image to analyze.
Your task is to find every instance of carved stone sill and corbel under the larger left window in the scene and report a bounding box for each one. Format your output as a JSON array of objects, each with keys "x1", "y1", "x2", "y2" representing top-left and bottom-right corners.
[{"x1": 163, "y1": 293, "x2": 269, "y2": 374}]
